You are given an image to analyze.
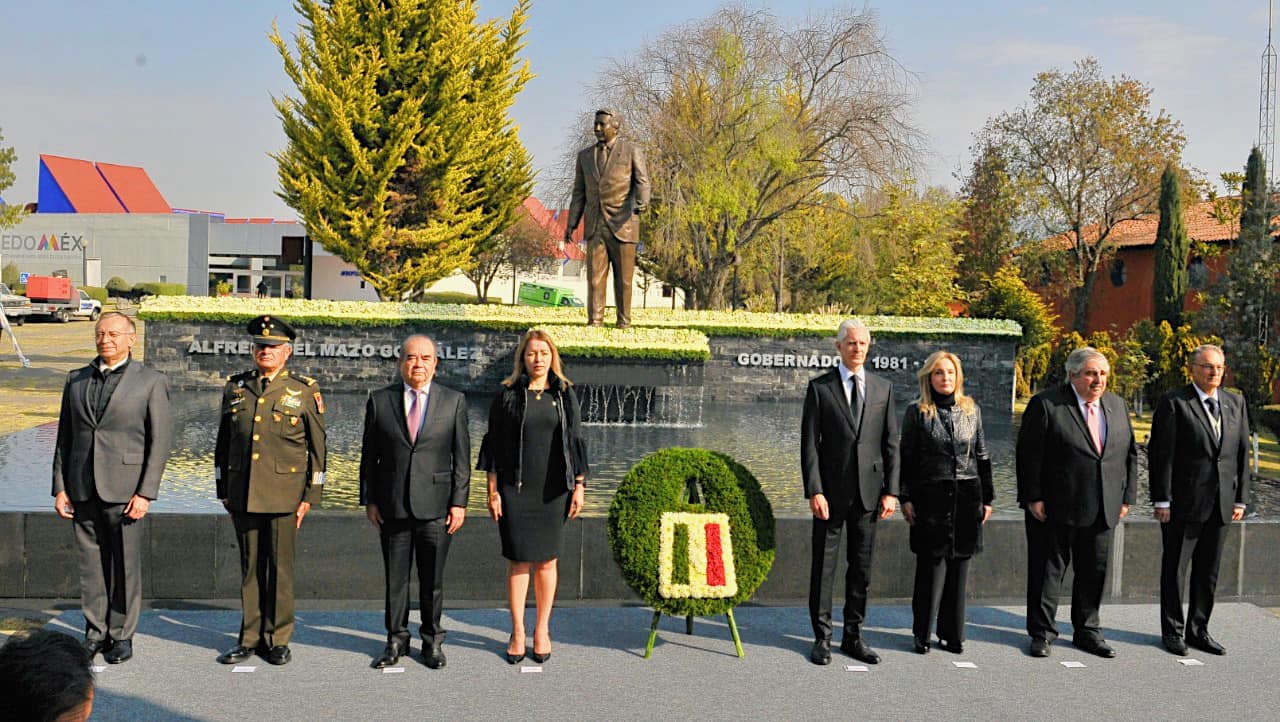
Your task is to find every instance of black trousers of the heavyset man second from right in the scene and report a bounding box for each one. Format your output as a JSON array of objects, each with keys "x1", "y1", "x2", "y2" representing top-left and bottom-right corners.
[{"x1": 1025, "y1": 512, "x2": 1111, "y2": 641}]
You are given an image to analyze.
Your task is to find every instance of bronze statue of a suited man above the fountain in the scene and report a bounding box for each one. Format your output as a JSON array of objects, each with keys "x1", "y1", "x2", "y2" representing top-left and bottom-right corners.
[{"x1": 564, "y1": 110, "x2": 649, "y2": 329}]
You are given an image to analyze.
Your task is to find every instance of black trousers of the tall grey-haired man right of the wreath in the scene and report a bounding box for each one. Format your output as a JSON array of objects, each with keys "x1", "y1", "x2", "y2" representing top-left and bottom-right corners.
[{"x1": 809, "y1": 504, "x2": 877, "y2": 643}]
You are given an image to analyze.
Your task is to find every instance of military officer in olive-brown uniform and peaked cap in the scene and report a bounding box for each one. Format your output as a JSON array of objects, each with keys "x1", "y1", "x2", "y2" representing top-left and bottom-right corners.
[{"x1": 214, "y1": 316, "x2": 325, "y2": 664}]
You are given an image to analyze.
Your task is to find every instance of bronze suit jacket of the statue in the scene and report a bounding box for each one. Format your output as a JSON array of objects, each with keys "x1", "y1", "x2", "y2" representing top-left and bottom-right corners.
[{"x1": 567, "y1": 138, "x2": 649, "y2": 243}]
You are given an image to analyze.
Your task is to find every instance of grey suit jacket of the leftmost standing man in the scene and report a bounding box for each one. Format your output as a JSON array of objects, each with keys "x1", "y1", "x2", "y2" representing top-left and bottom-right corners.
[{"x1": 54, "y1": 360, "x2": 173, "y2": 504}]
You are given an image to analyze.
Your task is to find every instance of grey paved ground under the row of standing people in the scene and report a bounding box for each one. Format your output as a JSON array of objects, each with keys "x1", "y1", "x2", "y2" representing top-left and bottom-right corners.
[{"x1": 2, "y1": 603, "x2": 1280, "y2": 721}]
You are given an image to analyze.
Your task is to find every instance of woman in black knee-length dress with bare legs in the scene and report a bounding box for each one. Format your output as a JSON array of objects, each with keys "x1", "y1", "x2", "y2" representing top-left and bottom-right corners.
[{"x1": 477, "y1": 329, "x2": 586, "y2": 664}]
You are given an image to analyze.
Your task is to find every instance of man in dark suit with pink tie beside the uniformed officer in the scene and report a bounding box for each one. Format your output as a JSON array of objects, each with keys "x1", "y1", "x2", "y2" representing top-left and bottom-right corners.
[{"x1": 360, "y1": 335, "x2": 471, "y2": 670}]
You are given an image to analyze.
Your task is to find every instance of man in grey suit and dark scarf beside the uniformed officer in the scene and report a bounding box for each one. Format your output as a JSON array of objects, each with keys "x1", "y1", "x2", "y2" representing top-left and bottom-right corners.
[{"x1": 54, "y1": 311, "x2": 173, "y2": 664}]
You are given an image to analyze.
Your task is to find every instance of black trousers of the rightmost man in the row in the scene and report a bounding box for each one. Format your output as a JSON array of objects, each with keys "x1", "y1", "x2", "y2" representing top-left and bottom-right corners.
[{"x1": 1160, "y1": 508, "x2": 1228, "y2": 638}]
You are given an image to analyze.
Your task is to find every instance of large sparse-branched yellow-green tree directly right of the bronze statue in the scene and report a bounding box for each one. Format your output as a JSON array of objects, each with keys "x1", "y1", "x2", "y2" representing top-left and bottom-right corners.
[{"x1": 595, "y1": 5, "x2": 919, "y2": 309}]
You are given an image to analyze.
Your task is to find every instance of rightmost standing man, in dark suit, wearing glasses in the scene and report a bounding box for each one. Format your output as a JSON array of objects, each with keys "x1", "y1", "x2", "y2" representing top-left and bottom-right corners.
[{"x1": 1147, "y1": 344, "x2": 1249, "y2": 655}]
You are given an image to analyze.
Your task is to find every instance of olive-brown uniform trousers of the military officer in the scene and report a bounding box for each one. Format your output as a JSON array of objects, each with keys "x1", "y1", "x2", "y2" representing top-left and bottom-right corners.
[{"x1": 232, "y1": 512, "x2": 298, "y2": 648}]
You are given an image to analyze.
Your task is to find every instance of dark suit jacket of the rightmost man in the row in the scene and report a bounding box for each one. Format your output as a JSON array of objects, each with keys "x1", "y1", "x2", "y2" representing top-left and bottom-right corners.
[{"x1": 1147, "y1": 384, "x2": 1249, "y2": 524}]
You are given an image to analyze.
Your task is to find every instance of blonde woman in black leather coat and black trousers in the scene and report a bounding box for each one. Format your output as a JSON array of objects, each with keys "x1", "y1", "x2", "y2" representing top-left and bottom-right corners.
[{"x1": 899, "y1": 351, "x2": 995, "y2": 654}]
